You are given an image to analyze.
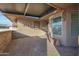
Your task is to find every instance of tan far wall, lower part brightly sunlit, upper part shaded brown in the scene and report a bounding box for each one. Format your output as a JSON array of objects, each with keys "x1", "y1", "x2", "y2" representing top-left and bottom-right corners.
[{"x1": 17, "y1": 19, "x2": 45, "y2": 36}]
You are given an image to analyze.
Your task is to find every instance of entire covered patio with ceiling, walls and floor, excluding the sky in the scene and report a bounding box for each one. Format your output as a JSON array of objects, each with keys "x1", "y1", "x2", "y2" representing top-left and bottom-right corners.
[{"x1": 0, "y1": 3, "x2": 79, "y2": 56}]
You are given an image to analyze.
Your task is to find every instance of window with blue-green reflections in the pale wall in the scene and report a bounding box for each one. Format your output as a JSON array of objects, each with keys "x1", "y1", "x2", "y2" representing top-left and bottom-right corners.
[{"x1": 52, "y1": 17, "x2": 62, "y2": 35}]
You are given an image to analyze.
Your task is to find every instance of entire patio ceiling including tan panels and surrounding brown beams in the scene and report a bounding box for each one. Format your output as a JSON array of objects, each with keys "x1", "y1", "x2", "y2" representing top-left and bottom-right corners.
[{"x1": 0, "y1": 3, "x2": 74, "y2": 20}]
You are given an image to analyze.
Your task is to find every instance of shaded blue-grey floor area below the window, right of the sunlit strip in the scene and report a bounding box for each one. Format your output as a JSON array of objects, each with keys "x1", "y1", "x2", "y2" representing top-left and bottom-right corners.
[{"x1": 55, "y1": 46, "x2": 78, "y2": 56}]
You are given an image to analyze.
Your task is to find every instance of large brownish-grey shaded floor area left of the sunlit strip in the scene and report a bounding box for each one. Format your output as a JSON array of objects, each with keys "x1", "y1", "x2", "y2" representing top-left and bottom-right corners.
[{"x1": 5, "y1": 32, "x2": 47, "y2": 56}]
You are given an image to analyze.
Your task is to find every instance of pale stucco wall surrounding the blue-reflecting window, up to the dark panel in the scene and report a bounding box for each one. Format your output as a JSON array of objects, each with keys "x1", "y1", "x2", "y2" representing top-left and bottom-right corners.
[{"x1": 49, "y1": 10, "x2": 77, "y2": 46}]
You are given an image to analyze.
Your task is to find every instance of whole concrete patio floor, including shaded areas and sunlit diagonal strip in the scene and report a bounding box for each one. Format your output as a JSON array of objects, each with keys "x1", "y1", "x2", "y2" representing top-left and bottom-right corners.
[{"x1": 0, "y1": 32, "x2": 78, "y2": 56}]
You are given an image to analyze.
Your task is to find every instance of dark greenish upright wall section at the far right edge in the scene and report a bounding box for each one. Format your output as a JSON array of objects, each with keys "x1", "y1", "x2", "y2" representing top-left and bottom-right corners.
[{"x1": 71, "y1": 10, "x2": 78, "y2": 46}]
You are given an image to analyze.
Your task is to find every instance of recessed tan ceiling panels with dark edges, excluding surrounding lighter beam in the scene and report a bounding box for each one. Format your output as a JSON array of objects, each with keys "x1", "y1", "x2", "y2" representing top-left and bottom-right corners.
[{"x1": 0, "y1": 3, "x2": 56, "y2": 17}]
